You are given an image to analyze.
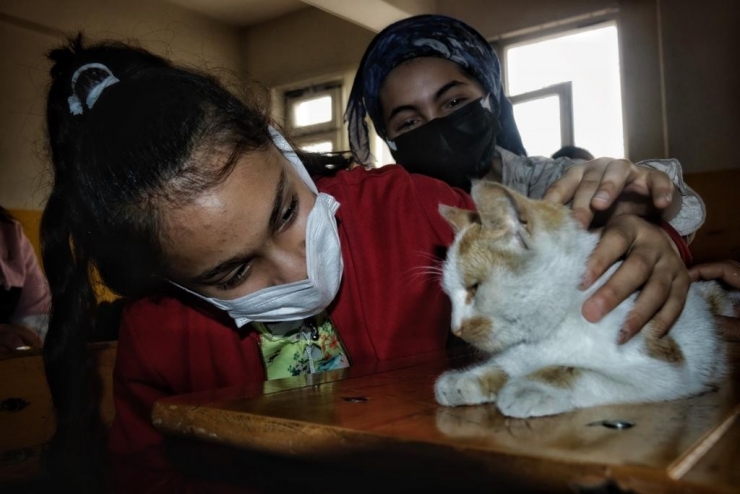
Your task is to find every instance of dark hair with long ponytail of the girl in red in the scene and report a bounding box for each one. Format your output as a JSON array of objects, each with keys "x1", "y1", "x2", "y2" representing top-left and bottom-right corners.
[{"x1": 41, "y1": 36, "x2": 271, "y2": 492}]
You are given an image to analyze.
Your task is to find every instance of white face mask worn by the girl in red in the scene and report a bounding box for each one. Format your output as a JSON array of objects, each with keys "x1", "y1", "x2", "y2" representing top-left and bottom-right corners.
[{"x1": 171, "y1": 127, "x2": 344, "y2": 327}]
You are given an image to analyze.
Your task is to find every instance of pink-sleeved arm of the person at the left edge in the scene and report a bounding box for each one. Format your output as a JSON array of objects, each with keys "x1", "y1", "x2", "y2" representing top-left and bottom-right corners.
[{"x1": 0, "y1": 222, "x2": 51, "y2": 352}]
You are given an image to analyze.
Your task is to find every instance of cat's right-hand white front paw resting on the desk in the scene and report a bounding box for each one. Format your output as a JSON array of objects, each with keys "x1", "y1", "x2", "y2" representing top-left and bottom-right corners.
[{"x1": 497, "y1": 380, "x2": 574, "y2": 418}]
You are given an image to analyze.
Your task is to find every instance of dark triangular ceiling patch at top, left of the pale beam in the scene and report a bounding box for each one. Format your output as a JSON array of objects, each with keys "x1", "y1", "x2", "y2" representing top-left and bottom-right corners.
[{"x1": 166, "y1": 0, "x2": 307, "y2": 27}]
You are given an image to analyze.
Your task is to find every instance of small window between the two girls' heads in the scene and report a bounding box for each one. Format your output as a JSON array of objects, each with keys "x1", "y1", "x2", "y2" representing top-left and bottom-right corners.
[{"x1": 284, "y1": 82, "x2": 342, "y2": 153}]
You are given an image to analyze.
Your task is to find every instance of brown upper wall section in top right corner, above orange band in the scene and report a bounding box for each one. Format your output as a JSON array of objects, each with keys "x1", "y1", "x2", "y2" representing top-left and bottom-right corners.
[{"x1": 660, "y1": 0, "x2": 740, "y2": 173}]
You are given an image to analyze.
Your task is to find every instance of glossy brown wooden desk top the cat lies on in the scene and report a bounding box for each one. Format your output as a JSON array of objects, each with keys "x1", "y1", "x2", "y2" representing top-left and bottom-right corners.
[{"x1": 153, "y1": 350, "x2": 740, "y2": 493}]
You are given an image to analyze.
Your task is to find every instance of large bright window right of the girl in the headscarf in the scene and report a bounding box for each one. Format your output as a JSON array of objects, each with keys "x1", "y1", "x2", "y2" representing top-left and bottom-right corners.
[{"x1": 504, "y1": 22, "x2": 625, "y2": 158}]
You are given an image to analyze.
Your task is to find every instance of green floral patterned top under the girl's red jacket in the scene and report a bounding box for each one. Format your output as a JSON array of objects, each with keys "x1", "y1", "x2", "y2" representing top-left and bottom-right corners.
[{"x1": 253, "y1": 312, "x2": 349, "y2": 380}]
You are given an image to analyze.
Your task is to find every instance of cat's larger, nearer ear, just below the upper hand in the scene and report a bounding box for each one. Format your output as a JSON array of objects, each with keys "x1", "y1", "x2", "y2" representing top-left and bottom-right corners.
[{"x1": 471, "y1": 180, "x2": 530, "y2": 248}]
